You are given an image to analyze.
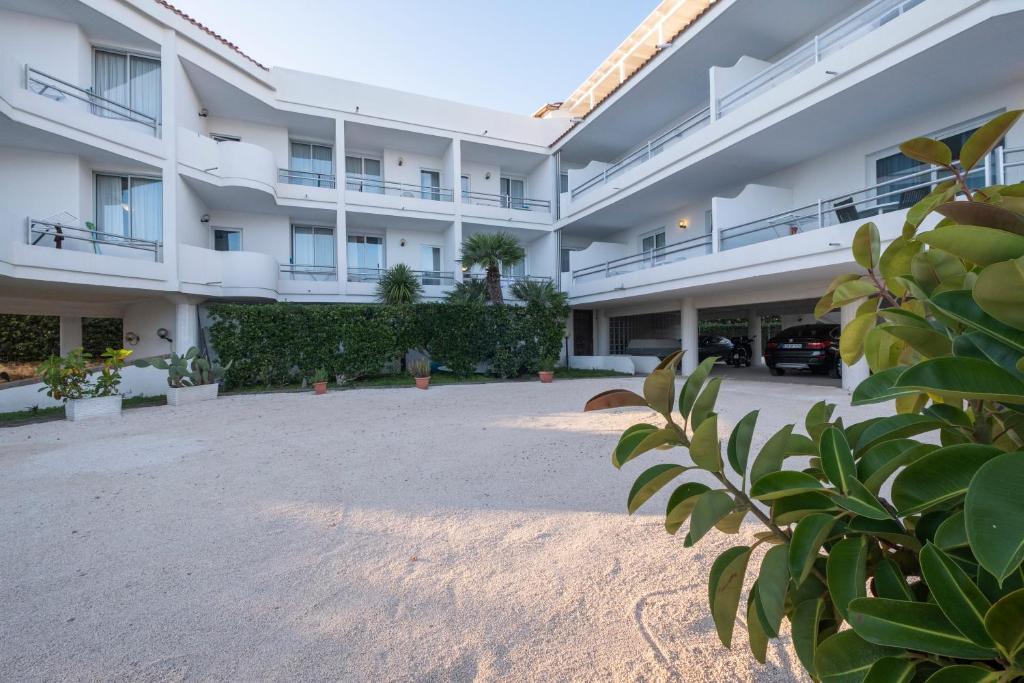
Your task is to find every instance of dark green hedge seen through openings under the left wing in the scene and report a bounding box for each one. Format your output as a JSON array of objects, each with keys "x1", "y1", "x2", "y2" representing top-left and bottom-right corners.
[{"x1": 0, "y1": 313, "x2": 124, "y2": 362}]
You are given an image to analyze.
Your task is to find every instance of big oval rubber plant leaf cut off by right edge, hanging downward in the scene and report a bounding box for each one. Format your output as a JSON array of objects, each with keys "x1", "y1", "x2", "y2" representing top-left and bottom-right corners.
[{"x1": 964, "y1": 449, "x2": 1024, "y2": 583}]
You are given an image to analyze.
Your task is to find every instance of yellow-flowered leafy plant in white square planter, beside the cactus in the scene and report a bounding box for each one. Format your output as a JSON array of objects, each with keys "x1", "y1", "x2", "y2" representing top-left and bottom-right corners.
[{"x1": 38, "y1": 348, "x2": 131, "y2": 422}]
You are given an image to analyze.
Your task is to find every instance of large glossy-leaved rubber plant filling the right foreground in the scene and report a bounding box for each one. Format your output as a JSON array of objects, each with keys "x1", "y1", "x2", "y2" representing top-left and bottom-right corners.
[{"x1": 586, "y1": 112, "x2": 1024, "y2": 681}]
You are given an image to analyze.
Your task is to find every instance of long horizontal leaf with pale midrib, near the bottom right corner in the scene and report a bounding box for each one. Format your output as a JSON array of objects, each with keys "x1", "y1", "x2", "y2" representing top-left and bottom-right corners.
[{"x1": 849, "y1": 598, "x2": 995, "y2": 659}]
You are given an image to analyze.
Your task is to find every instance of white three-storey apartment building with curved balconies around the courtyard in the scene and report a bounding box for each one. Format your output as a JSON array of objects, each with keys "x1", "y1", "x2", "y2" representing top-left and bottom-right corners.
[{"x1": 0, "y1": 0, "x2": 1024, "y2": 405}]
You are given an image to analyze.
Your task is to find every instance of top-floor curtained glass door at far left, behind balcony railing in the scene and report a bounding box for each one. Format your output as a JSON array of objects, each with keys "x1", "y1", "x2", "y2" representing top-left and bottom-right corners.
[{"x1": 92, "y1": 50, "x2": 160, "y2": 121}]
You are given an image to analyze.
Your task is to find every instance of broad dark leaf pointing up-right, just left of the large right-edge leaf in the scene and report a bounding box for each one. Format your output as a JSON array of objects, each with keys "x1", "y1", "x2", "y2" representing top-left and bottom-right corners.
[{"x1": 892, "y1": 443, "x2": 999, "y2": 516}]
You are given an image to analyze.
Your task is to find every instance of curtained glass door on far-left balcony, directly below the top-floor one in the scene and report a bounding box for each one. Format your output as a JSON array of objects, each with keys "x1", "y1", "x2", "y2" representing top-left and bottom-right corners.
[{"x1": 96, "y1": 174, "x2": 164, "y2": 242}]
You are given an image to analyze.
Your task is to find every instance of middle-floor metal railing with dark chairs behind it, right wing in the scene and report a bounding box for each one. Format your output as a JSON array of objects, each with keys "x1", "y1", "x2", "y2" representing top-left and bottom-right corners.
[{"x1": 720, "y1": 156, "x2": 994, "y2": 250}]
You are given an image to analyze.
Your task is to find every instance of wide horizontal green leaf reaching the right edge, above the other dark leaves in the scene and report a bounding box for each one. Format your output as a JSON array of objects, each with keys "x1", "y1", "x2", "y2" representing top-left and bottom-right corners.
[{"x1": 895, "y1": 356, "x2": 1024, "y2": 403}]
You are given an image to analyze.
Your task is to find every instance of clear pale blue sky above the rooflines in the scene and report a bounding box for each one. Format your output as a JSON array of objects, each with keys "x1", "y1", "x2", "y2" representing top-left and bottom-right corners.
[{"x1": 171, "y1": 0, "x2": 657, "y2": 114}]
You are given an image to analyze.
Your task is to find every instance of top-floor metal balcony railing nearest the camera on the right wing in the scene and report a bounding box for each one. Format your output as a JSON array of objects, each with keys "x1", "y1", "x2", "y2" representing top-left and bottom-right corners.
[{"x1": 717, "y1": 0, "x2": 924, "y2": 117}]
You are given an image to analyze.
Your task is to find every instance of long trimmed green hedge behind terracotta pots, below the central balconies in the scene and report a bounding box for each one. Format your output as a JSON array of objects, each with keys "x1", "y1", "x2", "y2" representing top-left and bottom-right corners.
[{"x1": 202, "y1": 303, "x2": 567, "y2": 387}]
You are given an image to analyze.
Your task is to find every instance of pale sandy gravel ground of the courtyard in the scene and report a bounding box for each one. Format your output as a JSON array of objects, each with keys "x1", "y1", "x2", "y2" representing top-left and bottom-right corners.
[{"x1": 0, "y1": 379, "x2": 888, "y2": 681}]
